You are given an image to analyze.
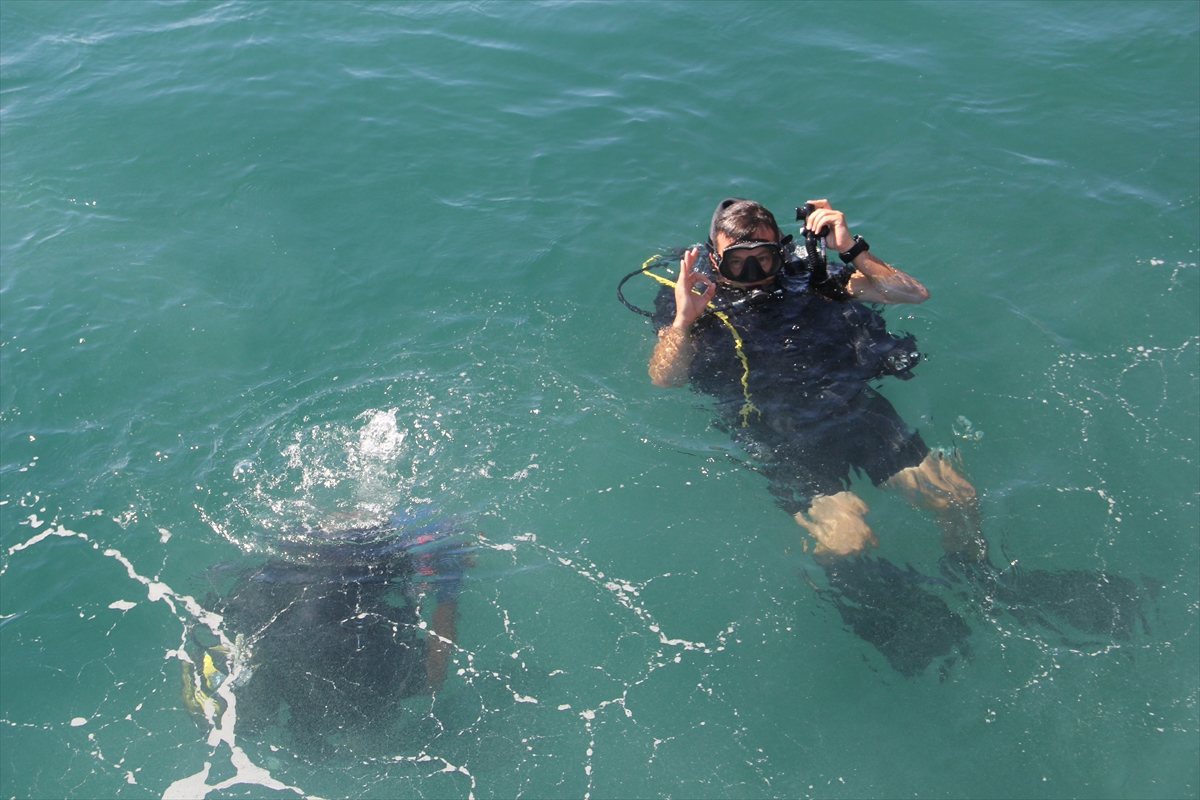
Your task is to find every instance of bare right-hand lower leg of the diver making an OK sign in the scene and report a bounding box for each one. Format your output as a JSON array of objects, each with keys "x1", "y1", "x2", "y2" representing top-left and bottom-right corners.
[{"x1": 887, "y1": 451, "x2": 988, "y2": 561}]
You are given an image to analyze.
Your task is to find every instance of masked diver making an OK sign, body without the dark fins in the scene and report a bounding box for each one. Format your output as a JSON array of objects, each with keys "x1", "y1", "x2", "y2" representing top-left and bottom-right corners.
[{"x1": 649, "y1": 198, "x2": 986, "y2": 560}]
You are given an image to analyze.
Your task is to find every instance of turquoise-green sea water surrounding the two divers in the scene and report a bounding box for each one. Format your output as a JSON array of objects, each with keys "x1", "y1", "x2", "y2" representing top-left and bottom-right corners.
[{"x1": 0, "y1": 0, "x2": 1200, "y2": 798}]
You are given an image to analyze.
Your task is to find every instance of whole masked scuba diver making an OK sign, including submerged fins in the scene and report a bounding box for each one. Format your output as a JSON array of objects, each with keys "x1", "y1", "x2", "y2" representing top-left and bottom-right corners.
[{"x1": 618, "y1": 198, "x2": 1140, "y2": 674}]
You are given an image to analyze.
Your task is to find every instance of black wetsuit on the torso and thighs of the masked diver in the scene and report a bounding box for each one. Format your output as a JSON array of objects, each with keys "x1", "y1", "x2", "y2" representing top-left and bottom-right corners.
[{"x1": 654, "y1": 264, "x2": 929, "y2": 513}]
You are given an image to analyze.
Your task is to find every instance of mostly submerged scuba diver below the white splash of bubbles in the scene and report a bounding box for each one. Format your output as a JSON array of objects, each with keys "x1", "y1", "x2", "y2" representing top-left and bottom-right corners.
[{"x1": 182, "y1": 513, "x2": 472, "y2": 753}]
